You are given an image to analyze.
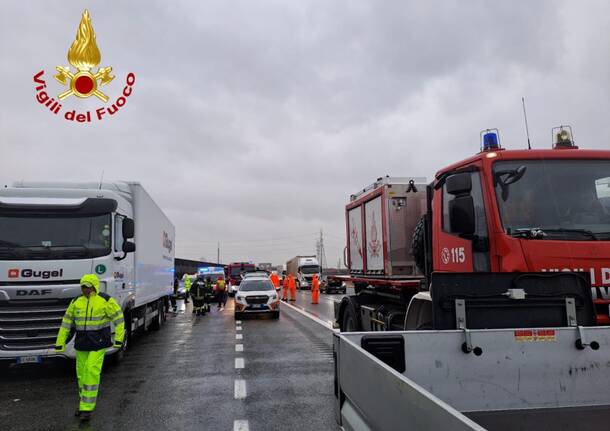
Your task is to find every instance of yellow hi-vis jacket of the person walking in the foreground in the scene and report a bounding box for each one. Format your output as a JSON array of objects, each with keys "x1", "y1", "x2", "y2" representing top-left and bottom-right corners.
[{"x1": 55, "y1": 293, "x2": 125, "y2": 351}]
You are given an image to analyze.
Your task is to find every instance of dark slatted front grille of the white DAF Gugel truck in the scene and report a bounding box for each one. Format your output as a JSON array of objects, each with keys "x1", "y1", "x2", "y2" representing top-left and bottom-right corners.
[{"x1": 0, "y1": 299, "x2": 70, "y2": 350}]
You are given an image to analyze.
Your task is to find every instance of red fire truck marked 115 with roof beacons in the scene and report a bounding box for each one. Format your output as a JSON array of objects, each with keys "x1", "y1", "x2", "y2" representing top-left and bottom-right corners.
[{"x1": 335, "y1": 126, "x2": 610, "y2": 331}]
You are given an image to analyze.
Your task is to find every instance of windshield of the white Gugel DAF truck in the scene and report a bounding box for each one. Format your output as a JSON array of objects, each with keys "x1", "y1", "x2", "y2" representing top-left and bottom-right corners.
[{"x1": 0, "y1": 214, "x2": 112, "y2": 260}]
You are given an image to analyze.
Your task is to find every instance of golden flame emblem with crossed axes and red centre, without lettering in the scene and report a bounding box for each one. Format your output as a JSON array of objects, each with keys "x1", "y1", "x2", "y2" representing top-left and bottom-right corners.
[{"x1": 55, "y1": 9, "x2": 114, "y2": 102}]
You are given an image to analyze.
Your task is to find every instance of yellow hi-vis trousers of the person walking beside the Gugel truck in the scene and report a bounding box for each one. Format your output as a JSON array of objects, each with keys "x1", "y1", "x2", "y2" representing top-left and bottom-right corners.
[{"x1": 76, "y1": 349, "x2": 106, "y2": 412}]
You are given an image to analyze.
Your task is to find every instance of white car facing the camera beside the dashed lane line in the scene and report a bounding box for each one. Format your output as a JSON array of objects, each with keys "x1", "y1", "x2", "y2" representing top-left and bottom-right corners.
[{"x1": 235, "y1": 277, "x2": 280, "y2": 319}]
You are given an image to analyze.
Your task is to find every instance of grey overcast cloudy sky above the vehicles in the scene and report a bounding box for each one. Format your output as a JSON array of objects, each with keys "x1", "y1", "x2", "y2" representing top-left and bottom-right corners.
[{"x1": 0, "y1": 0, "x2": 610, "y2": 265}]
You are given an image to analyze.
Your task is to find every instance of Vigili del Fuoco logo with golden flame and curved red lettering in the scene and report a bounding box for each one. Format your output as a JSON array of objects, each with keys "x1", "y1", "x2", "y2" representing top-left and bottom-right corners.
[{"x1": 34, "y1": 9, "x2": 136, "y2": 123}]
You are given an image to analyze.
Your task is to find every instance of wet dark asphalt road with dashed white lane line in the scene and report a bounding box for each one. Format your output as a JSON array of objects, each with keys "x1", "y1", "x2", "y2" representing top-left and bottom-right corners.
[{"x1": 0, "y1": 298, "x2": 339, "y2": 431}]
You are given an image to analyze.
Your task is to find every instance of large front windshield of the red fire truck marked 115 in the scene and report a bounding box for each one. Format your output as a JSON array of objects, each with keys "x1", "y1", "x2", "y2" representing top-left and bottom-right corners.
[{"x1": 494, "y1": 160, "x2": 610, "y2": 240}]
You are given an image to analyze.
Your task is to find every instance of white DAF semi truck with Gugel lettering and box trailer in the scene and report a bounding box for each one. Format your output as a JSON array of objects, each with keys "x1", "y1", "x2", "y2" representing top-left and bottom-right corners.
[{"x1": 0, "y1": 182, "x2": 175, "y2": 363}]
